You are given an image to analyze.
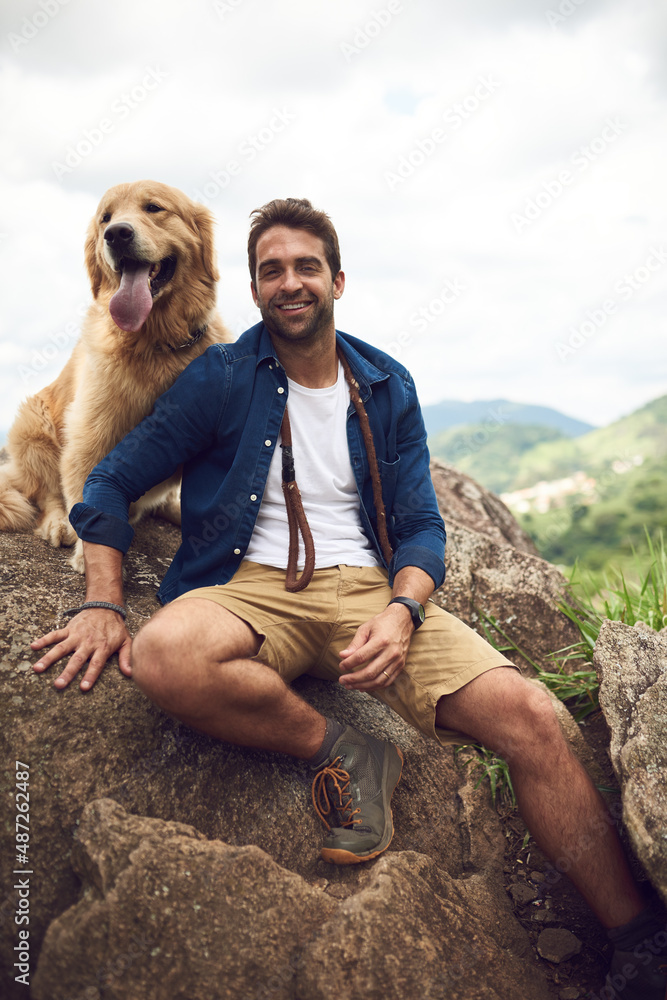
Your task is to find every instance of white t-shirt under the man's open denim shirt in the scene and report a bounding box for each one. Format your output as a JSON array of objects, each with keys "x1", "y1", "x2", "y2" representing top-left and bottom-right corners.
[{"x1": 245, "y1": 362, "x2": 381, "y2": 570}]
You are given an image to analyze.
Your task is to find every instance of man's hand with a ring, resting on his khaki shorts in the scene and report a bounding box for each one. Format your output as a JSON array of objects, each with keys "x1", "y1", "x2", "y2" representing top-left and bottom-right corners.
[{"x1": 339, "y1": 604, "x2": 415, "y2": 691}]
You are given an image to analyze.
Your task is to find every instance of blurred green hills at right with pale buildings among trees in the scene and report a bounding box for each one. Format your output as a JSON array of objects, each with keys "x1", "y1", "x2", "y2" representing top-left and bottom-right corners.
[{"x1": 429, "y1": 396, "x2": 667, "y2": 571}]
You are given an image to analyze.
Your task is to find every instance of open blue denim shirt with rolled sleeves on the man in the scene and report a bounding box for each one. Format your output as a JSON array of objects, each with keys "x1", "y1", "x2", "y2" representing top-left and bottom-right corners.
[{"x1": 70, "y1": 323, "x2": 445, "y2": 604}]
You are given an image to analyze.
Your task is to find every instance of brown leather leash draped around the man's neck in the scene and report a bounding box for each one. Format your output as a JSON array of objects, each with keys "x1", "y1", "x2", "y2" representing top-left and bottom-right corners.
[{"x1": 280, "y1": 348, "x2": 393, "y2": 593}]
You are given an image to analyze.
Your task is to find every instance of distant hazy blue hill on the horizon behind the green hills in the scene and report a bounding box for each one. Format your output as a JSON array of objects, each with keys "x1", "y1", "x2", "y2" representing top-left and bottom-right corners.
[{"x1": 422, "y1": 399, "x2": 594, "y2": 437}]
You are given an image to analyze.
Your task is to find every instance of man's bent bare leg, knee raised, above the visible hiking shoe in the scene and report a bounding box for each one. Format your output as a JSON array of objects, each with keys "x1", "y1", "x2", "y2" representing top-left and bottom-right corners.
[{"x1": 132, "y1": 597, "x2": 326, "y2": 759}]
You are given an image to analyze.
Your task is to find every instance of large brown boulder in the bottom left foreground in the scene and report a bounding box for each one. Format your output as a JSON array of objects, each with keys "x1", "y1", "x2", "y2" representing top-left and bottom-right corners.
[{"x1": 32, "y1": 799, "x2": 340, "y2": 1000}]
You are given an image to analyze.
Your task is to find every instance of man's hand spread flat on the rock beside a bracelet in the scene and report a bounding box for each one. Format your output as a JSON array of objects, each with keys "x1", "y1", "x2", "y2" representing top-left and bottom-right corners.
[{"x1": 30, "y1": 608, "x2": 132, "y2": 691}]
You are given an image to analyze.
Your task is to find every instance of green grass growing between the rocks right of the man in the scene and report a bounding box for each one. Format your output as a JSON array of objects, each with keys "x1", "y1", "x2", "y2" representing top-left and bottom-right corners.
[{"x1": 456, "y1": 530, "x2": 667, "y2": 807}]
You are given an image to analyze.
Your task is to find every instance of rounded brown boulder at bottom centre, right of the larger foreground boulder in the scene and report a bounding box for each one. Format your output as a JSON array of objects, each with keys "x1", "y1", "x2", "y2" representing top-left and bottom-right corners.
[{"x1": 296, "y1": 852, "x2": 549, "y2": 1000}]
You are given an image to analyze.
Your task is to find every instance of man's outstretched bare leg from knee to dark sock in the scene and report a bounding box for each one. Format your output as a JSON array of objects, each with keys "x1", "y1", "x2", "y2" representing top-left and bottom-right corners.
[{"x1": 436, "y1": 668, "x2": 646, "y2": 929}]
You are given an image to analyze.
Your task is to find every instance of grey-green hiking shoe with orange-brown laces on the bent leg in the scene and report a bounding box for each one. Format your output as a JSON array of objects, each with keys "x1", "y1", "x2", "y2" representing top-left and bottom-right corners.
[{"x1": 312, "y1": 726, "x2": 403, "y2": 865}]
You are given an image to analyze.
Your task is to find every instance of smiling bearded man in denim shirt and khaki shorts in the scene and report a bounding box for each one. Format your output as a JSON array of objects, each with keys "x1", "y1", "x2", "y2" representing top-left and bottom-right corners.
[{"x1": 33, "y1": 199, "x2": 665, "y2": 1000}]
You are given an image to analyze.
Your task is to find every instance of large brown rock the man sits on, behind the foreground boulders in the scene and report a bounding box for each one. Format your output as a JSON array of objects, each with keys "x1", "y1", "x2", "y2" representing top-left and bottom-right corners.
[{"x1": 0, "y1": 518, "x2": 552, "y2": 1000}]
